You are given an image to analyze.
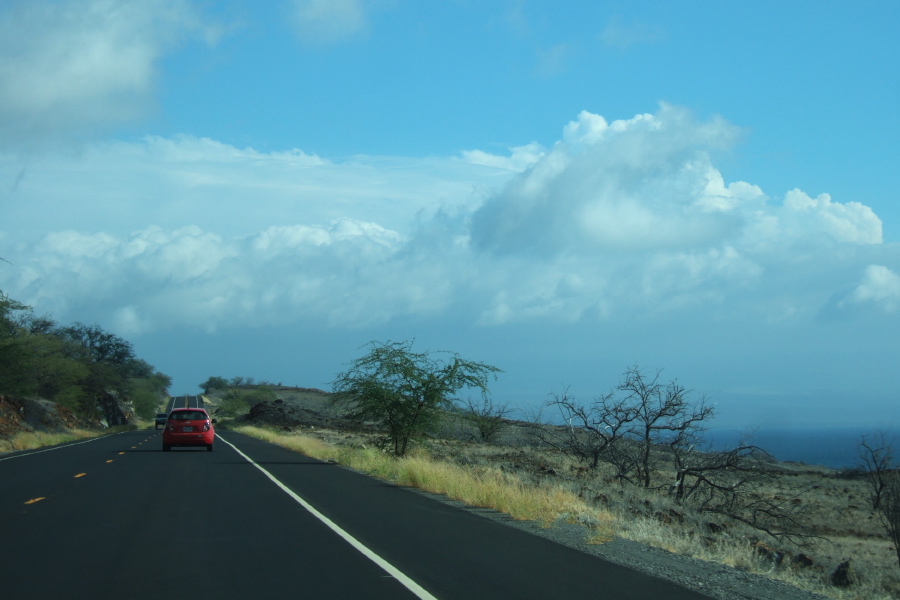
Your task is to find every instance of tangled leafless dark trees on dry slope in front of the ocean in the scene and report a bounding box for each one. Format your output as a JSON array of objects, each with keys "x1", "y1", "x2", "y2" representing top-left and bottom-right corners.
[{"x1": 535, "y1": 366, "x2": 809, "y2": 542}]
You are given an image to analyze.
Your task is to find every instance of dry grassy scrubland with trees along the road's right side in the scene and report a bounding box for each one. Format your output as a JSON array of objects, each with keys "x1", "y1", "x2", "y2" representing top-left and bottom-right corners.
[{"x1": 207, "y1": 343, "x2": 900, "y2": 600}]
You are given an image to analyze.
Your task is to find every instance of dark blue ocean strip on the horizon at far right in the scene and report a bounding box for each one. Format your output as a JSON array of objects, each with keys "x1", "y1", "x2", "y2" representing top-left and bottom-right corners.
[{"x1": 706, "y1": 427, "x2": 900, "y2": 469}]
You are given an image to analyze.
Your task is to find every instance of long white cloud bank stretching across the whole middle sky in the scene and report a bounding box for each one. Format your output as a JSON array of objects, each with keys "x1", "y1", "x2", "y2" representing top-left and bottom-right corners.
[{"x1": 0, "y1": 106, "x2": 900, "y2": 334}]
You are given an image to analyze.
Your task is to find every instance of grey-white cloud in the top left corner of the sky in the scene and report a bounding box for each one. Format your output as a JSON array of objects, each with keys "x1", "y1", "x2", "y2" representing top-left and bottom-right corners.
[{"x1": 0, "y1": 0, "x2": 216, "y2": 148}]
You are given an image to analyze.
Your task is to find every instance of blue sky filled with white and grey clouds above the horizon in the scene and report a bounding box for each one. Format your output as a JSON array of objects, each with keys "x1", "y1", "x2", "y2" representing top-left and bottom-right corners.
[{"x1": 0, "y1": 0, "x2": 900, "y2": 429}]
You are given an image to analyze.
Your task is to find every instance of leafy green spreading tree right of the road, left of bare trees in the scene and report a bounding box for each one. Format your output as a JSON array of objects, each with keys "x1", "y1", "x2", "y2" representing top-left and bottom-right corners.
[{"x1": 332, "y1": 341, "x2": 500, "y2": 456}]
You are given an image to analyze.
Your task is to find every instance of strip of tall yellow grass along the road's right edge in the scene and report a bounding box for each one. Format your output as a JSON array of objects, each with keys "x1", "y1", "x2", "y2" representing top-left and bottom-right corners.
[{"x1": 235, "y1": 426, "x2": 614, "y2": 543}]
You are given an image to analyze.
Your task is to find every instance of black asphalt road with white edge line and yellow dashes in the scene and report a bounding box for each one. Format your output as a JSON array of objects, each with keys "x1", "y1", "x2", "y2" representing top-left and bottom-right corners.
[{"x1": 0, "y1": 430, "x2": 705, "y2": 600}]
